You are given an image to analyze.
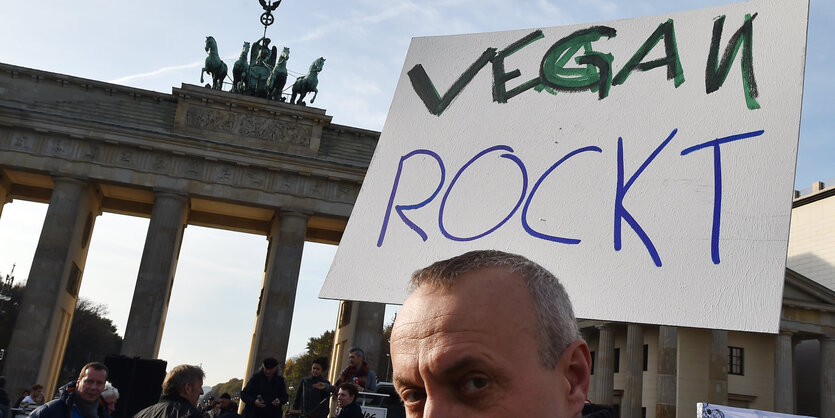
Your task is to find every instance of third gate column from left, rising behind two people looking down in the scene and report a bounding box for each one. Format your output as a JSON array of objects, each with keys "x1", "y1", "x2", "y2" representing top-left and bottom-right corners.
[{"x1": 245, "y1": 211, "x2": 309, "y2": 379}]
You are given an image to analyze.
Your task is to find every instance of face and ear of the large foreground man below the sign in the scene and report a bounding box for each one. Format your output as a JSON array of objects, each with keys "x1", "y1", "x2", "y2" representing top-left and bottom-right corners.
[{"x1": 391, "y1": 268, "x2": 588, "y2": 417}]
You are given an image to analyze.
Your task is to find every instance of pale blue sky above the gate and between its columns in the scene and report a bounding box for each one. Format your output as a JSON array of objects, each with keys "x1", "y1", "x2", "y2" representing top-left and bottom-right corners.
[{"x1": 0, "y1": 0, "x2": 835, "y2": 384}]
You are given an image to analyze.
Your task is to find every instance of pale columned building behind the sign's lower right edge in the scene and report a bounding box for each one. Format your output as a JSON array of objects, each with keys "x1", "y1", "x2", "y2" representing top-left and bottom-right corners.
[{"x1": 580, "y1": 182, "x2": 835, "y2": 418}]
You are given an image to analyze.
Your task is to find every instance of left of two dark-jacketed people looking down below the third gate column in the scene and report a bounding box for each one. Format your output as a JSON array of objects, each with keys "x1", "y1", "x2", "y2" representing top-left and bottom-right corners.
[{"x1": 241, "y1": 357, "x2": 290, "y2": 418}]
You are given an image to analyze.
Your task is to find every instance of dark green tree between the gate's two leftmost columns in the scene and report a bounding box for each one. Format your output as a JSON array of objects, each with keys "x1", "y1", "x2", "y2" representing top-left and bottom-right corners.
[{"x1": 56, "y1": 298, "x2": 122, "y2": 386}]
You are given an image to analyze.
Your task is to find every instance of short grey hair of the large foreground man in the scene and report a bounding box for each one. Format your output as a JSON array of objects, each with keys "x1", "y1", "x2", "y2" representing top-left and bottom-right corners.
[{"x1": 411, "y1": 250, "x2": 581, "y2": 369}]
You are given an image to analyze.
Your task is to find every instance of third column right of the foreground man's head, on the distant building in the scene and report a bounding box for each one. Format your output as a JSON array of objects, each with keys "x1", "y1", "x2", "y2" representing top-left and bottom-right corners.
[{"x1": 655, "y1": 326, "x2": 678, "y2": 418}]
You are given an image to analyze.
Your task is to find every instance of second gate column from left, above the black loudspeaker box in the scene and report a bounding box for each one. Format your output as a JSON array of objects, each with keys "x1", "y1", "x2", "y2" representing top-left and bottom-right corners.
[{"x1": 122, "y1": 192, "x2": 188, "y2": 358}]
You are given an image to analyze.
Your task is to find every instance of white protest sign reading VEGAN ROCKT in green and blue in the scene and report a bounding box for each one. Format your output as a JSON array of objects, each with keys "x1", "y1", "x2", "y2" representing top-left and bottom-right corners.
[{"x1": 320, "y1": 0, "x2": 808, "y2": 332}]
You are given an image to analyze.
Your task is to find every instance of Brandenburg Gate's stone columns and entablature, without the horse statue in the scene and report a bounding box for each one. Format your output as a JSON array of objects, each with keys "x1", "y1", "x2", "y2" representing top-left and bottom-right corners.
[{"x1": 0, "y1": 64, "x2": 384, "y2": 394}]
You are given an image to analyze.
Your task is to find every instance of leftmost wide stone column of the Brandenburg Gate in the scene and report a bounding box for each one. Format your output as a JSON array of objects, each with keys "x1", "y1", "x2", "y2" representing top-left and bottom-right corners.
[{"x1": 5, "y1": 177, "x2": 101, "y2": 397}]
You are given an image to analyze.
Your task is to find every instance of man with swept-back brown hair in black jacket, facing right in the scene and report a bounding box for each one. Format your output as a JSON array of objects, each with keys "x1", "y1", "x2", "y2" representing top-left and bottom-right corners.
[{"x1": 133, "y1": 364, "x2": 206, "y2": 418}]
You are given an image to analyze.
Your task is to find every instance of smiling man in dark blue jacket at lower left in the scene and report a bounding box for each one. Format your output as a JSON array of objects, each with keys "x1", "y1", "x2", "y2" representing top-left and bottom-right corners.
[{"x1": 29, "y1": 363, "x2": 110, "y2": 418}]
